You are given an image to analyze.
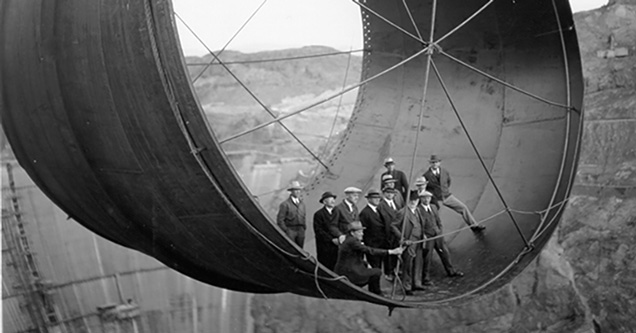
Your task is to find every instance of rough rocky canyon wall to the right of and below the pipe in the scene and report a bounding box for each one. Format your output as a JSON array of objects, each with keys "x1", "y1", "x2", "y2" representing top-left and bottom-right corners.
[{"x1": 251, "y1": 0, "x2": 636, "y2": 333}]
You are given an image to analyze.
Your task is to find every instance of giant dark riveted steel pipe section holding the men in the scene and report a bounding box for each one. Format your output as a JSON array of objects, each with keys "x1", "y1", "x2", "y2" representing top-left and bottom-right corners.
[{"x1": 0, "y1": 0, "x2": 582, "y2": 307}]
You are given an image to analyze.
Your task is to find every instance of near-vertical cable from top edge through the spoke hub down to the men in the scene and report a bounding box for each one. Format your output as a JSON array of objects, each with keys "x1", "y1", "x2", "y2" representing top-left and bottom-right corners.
[{"x1": 391, "y1": 0, "x2": 437, "y2": 296}]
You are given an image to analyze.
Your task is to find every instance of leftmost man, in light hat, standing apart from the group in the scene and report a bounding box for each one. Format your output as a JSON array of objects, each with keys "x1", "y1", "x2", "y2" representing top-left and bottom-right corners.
[{"x1": 276, "y1": 181, "x2": 305, "y2": 248}]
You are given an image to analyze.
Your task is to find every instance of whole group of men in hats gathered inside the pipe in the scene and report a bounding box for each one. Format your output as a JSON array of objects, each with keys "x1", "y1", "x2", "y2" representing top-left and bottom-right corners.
[{"x1": 277, "y1": 155, "x2": 485, "y2": 295}]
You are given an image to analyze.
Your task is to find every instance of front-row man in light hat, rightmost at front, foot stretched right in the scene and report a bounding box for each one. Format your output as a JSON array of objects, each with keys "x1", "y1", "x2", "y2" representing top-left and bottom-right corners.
[{"x1": 418, "y1": 191, "x2": 464, "y2": 285}]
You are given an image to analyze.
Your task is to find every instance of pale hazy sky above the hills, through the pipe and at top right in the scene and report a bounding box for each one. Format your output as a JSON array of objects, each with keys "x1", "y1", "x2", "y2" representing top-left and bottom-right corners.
[{"x1": 173, "y1": 0, "x2": 607, "y2": 55}]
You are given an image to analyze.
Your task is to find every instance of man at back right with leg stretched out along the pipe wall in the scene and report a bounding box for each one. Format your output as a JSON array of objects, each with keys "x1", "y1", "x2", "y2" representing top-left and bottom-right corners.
[{"x1": 424, "y1": 155, "x2": 486, "y2": 232}]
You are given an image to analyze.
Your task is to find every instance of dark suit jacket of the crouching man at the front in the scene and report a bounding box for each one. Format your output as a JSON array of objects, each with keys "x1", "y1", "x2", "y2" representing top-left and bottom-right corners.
[{"x1": 334, "y1": 234, "x2": 389, "y2": 285}]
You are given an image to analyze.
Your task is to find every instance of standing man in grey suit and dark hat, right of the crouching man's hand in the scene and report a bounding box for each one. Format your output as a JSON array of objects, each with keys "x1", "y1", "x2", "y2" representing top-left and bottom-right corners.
[{"x1": 391, "y1": 191, "x2": 424, "y2": 295}]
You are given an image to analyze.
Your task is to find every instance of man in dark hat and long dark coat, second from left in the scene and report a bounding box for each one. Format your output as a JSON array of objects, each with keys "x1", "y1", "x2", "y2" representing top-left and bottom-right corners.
[{"x1": 314, "y1": 192, "x2": 345, "y2": 270}]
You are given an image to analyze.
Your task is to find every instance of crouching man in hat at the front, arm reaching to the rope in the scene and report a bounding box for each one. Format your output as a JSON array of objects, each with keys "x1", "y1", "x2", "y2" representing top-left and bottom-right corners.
[{"x1": 334, "y1": 221, "x2": 404, "y2": 296}]
